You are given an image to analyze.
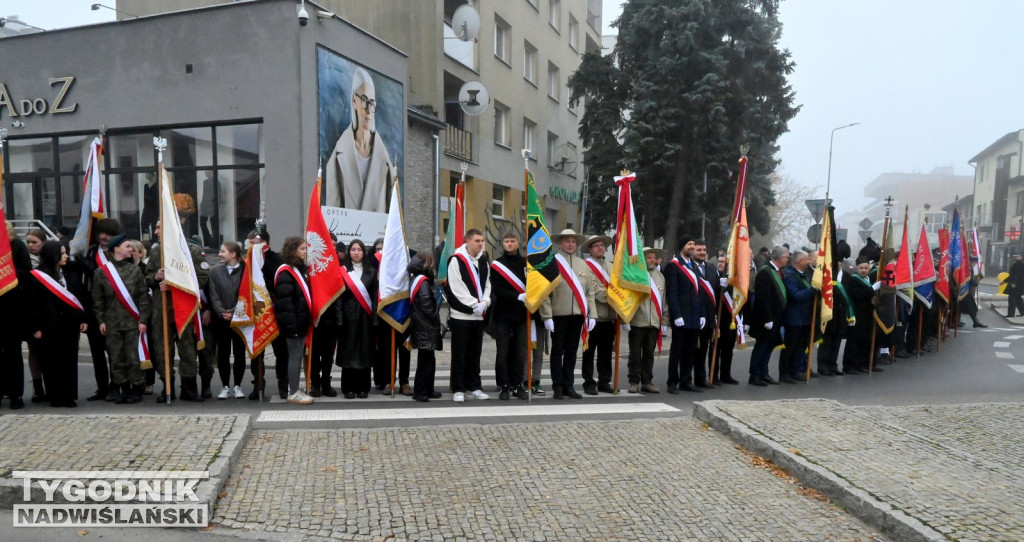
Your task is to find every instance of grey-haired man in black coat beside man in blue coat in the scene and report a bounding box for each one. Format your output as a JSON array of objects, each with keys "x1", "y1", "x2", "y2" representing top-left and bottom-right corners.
[{"x1": 748, "y1": 247, "x2": 790, "y2": 386}]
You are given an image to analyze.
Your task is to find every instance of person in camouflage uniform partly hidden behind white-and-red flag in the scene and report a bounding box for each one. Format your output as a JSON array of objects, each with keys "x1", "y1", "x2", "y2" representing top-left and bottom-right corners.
[{"x1": 145, "y1": 217, "x2": 212, "y2": 403}]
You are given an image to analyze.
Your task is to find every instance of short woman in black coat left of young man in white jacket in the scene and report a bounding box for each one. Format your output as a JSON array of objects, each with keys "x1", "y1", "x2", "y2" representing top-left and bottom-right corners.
[{"x1": 409, "y1": 251, "x2": 441, "y2": 403}]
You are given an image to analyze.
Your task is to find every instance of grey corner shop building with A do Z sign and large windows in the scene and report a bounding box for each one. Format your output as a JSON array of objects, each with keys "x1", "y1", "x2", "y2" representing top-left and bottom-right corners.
[{"x1": 0, "y1": 0, "x2": 434, "y2": 247}]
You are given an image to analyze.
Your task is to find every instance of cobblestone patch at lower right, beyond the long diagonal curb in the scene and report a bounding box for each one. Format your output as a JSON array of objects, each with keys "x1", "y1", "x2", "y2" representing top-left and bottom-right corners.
[{"x1": 715, "y1": 400, "x2": 1024, "y2": 541}]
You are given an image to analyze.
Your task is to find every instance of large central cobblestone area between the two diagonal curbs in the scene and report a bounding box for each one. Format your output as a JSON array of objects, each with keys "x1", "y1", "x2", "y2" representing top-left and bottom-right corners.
[{"x1": 214, "y1": 418, "x2": 881, "y2": 541}]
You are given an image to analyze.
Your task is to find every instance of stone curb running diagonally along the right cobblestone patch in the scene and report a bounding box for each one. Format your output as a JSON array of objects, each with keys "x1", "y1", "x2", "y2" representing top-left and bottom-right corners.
[{"x1": 693, "y1": 400, "x2": 948, "y2": 542}]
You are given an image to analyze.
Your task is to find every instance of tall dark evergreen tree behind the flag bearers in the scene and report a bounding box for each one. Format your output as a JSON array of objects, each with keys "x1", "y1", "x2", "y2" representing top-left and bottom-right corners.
[{"x1": 569, "y1": 0, "x2": 799, "y2": 251}]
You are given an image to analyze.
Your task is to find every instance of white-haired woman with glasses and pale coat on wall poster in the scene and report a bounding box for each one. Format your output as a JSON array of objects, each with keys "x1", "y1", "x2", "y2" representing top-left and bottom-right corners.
[{"x1": 326, "y1": 68, "x2": 392, "y2": 213}]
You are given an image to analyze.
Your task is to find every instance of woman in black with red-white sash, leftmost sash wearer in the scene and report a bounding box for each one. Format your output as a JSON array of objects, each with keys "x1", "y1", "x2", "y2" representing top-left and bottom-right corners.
[{"x1": 29, "y1": 241, "x2": 86, "y2": 407}]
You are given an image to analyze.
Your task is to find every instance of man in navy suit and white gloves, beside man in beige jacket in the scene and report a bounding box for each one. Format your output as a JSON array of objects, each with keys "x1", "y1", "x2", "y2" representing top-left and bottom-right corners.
[{"x1": 664, "y1": 236, "x2": 708, "y2": 393}]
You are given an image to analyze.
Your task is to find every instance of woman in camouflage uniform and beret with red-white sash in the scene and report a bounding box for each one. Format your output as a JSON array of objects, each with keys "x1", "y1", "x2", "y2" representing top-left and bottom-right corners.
[{"x1": 92, "y1": 234, "x2": 152, "y2": 404}]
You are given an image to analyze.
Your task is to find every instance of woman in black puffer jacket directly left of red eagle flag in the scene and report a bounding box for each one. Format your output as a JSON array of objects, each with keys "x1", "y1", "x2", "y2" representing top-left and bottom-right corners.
[{"x1": 273, "y1": 237, "x2": 313, "y2": 405}]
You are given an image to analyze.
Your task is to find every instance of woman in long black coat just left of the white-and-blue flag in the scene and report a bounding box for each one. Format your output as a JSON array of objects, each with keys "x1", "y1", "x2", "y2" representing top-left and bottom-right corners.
[{"x1": 335, "y1": 239, "x2": 377, "y2": 399}]
